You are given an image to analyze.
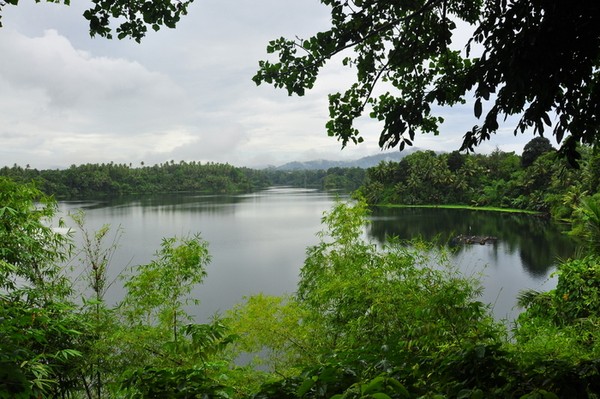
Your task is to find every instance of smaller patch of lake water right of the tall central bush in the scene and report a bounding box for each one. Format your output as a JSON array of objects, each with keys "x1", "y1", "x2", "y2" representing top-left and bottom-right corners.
[{"x1": 368, "y1": 208, "x2": 575, "y2": 320}]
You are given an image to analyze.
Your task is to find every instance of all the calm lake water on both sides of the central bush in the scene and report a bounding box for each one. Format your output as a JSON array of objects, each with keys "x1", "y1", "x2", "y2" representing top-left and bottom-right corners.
[{"x1": 60, "y1": 188, "x2": 573, "y2": 321}]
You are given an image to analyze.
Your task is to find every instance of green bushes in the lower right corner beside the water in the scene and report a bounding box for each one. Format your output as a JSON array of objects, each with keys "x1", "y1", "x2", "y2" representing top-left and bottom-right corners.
[{"x1": 515, "y1": 255, "x2": 600, "y2": 397}]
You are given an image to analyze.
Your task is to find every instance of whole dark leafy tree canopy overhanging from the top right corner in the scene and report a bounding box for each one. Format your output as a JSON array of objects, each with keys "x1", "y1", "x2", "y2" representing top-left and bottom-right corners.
[{"x1": 253, "y1": 0, "x2": 600, "y2": 164}]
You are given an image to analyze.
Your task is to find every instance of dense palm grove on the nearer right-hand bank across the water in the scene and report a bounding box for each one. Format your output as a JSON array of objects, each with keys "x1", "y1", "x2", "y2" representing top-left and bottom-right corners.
[{"x1": 358, "y1": 138, "x2": 598, "y2": 219}]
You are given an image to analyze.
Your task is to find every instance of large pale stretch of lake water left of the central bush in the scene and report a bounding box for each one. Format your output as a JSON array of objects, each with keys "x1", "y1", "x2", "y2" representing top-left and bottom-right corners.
[{"x1": 60, "y1": 188, "x2": 337, "y2": 321}]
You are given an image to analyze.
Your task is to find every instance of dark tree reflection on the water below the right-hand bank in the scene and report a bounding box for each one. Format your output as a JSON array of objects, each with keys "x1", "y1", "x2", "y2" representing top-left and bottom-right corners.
[{"x1": 367, "y1": 207, "x2": 575, "y2": 276}]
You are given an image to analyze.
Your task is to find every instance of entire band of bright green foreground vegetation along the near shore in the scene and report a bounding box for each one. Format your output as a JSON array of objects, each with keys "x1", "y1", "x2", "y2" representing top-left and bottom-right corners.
[{"x1": 0, "y1": 178, "x2": 600, "y2": 399}]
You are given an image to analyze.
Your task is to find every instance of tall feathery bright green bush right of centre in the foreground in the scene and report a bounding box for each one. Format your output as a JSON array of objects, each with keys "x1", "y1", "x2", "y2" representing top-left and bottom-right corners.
[{"x1": 297, "y1": 201, "x2": 500, "y2": 359}]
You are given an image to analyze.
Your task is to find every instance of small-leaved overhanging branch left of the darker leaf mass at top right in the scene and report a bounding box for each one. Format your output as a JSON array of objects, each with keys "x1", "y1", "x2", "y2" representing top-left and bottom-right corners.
[{"x1": 253, "y1": 0, "x2": 481, "y2": 149}]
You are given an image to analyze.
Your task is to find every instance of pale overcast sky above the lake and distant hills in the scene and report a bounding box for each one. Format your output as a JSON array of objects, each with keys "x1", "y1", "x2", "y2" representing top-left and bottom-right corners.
[{"x1": 0, "y1": 0, "x2": 533, "y2": 169}]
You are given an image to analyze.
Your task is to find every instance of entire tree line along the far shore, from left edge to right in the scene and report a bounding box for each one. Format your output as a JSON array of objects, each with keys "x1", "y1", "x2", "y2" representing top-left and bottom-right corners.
[{"x1": 0, "y1": 137, "x2": 600, "y2": 225}]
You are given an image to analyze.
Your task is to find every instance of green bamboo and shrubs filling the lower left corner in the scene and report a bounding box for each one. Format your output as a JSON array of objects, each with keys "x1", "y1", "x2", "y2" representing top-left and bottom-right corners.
[{"x1": 0, "y1": 178, "x2": 233, "y2": 399}]
